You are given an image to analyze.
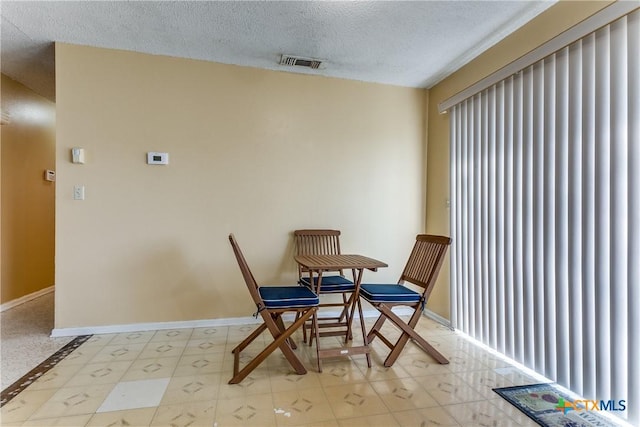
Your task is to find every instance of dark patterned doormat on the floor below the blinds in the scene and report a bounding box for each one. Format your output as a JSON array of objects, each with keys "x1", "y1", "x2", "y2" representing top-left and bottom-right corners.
[{"x1": 493, "y1": 383, "x2": 623, "y2": 427}]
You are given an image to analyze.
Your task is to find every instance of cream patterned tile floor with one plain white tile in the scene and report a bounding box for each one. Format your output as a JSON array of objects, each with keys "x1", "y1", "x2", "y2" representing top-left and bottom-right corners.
[{"x1": 1, "y1": 312, "x2": 552, "y2": 427}]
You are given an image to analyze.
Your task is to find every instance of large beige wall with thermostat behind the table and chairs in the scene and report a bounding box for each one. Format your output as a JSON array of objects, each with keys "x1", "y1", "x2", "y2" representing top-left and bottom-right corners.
[{"x1": 56, "y1": 44, "x2": 426, "y2": 328}]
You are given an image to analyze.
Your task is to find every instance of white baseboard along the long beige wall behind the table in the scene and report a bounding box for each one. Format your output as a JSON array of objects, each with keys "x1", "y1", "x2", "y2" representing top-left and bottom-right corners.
[{"x1": 51, "y1": 309, "x2": 411, "y2": 338}]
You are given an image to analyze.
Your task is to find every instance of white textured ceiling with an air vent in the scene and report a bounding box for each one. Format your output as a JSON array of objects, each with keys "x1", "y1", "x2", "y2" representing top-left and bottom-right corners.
[{"x1": 0, "y1": 1, "x2": 553, "y2": 100}]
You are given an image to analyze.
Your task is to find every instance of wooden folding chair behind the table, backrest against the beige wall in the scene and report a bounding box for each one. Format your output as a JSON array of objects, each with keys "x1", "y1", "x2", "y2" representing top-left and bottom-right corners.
[{"x1": 293, "y1": 229, "x2": 355, "y2": 345}]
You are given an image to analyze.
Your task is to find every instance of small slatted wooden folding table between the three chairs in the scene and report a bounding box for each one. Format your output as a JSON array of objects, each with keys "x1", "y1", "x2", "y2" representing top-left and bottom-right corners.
[{"x1": 294, "y1": 254, "x2": 387, "y2": 372}]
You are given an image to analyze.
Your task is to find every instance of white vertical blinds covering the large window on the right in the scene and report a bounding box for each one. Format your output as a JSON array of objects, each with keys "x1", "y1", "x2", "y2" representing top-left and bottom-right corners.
[{"x1": 450, "y1": 10, "x2": 640, "y2": 424}]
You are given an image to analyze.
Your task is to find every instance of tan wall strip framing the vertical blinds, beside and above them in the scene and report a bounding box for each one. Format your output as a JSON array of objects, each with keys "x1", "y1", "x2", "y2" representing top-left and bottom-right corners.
[{"x1": 427, "y1": 1, "x2": 612, "y2": 318}]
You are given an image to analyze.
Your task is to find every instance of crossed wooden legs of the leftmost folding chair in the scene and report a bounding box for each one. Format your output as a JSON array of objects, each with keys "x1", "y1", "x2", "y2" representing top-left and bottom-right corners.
[{"x1": 229, "y1": 307, "x2": 317, "y2": 384}]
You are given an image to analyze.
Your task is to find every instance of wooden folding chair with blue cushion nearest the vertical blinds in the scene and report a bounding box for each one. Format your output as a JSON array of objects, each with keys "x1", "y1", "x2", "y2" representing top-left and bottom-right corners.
[{"x1": 360, "y1": 234, "x2": 451, "y2": 367}]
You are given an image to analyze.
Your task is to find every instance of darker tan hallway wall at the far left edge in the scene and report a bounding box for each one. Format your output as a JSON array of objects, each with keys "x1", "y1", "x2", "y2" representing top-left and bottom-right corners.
[{"x1": 0, "y1": 74, "x2": 55, "y2": 304}]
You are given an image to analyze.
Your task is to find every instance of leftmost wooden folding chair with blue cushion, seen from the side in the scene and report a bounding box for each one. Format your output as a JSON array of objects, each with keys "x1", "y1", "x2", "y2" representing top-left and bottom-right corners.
[{"x1": 229, "y1": 234, "x2": 320, "y2": 384}]
